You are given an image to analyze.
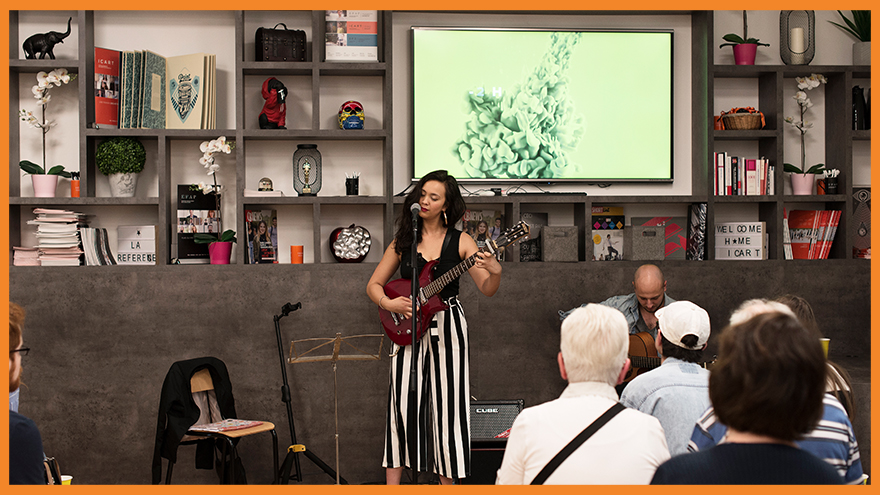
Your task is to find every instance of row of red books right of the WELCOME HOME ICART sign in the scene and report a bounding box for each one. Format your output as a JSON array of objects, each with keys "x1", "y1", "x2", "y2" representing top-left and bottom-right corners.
[{"x1": 787, "y1": 210, "x2": 840, "y2": 260}]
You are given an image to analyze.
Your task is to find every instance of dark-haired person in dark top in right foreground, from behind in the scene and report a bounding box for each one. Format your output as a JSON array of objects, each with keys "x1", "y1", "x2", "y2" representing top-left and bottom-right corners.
[{"x1": 651, "y1": 311, "x2": 843, "y2": 485}]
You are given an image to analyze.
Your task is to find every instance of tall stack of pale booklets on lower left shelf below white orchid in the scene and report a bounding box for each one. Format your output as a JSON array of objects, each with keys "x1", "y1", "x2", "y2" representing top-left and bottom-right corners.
[{"x1": 28, "y1": 208, "x2": 86, "y2": 266}]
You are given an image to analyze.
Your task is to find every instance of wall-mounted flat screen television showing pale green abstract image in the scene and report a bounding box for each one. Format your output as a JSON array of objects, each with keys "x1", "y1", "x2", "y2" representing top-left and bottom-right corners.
[{"x1": 412, "y1": 27, "x2": 673, "y2": 184}]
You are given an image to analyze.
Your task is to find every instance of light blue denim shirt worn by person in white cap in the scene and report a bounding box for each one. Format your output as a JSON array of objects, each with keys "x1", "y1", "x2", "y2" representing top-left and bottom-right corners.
[{"x1": 620, "y1": 358, "x2": 711, "y2": 456}]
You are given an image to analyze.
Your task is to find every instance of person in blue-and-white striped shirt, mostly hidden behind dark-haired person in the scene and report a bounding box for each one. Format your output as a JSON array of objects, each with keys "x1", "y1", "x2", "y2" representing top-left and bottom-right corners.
[{"x1": 688, "y1": 299, "x2": 866, "y2": 484}]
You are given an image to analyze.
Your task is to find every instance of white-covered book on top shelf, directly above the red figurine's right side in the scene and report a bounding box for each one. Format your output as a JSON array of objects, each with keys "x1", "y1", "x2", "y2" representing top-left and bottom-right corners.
[{"x1": 324, "y1": 10, "x2": 379, "y2": 62}]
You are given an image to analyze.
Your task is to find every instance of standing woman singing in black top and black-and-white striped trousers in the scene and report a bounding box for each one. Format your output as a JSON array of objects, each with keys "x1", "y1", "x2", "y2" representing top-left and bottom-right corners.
[{"x1": 367, "y1": 170, "x2": 501, "y2": 485}]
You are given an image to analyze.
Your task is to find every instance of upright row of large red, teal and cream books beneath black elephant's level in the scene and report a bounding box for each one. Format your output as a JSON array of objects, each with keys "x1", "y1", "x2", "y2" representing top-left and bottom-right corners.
[{"x1": 95, "y1": 47, "x2": 217, "y2": 129}]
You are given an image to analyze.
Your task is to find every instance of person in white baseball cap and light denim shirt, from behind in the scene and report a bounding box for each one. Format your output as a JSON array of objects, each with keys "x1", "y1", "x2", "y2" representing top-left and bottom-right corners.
[{"x1": 620, "y1": 301, "x2": 710, "y2": 456}]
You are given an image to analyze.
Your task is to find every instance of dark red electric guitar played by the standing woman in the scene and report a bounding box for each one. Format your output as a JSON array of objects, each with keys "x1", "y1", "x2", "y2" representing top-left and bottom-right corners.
[{"x1": 379, "y1": 221, "x2": 529, "y2": 346}]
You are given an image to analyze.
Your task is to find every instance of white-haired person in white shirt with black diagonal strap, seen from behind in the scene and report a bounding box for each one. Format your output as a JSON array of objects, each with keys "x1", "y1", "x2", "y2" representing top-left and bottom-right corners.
[{"x1": 497, "y1": 304, "x2": 669, "y2": 485}]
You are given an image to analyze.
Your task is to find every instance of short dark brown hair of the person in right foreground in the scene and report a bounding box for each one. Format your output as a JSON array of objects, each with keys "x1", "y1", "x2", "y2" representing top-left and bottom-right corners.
[{"x1": 709, "y1": 313, "x2": 826, "y2": 441}]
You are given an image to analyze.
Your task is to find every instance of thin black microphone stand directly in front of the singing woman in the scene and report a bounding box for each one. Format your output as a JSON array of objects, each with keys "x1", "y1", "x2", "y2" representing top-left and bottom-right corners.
[{"x1": 407, "y1": 203, "x2": 421, "y2": 485}]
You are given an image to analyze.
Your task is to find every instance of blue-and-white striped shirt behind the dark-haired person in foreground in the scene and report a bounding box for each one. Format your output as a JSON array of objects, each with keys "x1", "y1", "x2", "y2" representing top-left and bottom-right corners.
[{"x1": 688, "y1": 393, "x2": 866, "y2": 484}]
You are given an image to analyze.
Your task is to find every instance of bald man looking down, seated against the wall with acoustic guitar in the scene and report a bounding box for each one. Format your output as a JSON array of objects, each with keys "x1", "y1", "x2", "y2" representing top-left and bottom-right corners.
[{"x1": 559, "y1": 265, "x2": 675, "y2": 339}]
